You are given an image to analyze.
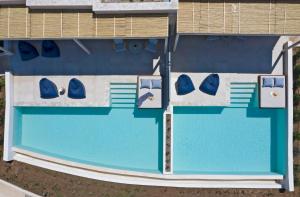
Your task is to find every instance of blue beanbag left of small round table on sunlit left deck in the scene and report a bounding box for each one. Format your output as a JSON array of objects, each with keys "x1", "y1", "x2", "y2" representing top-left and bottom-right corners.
[{"x1": 40, "y1": 78, "x2": 58, "y2": 99}]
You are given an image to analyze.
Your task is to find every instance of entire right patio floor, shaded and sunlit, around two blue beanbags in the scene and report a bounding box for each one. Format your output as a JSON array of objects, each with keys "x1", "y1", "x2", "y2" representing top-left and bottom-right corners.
[{"x1": 170, "y1": 36, "x2": 288, "y2": 106}]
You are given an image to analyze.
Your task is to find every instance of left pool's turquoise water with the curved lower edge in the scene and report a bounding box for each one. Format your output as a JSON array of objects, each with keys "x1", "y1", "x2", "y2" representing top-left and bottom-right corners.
[{"x1": 14, "y1": 107, "x2": 163, "y2": 173}]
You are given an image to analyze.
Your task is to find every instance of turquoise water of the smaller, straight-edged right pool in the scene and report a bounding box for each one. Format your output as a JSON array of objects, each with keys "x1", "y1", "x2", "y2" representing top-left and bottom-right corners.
[{"x1": 174, "y1": 106, "x2": 286, "y2": 174}]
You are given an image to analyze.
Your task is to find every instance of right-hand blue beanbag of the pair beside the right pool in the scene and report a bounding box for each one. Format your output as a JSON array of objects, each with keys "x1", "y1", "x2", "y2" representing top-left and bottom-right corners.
[{"x1": 199, "y1": 74, "x2": 220, "y2": 96}]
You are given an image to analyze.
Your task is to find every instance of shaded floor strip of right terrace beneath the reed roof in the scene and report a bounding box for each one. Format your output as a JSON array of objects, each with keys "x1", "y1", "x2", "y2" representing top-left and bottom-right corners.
[{"x1": 172, "y1": 36, "x2": 284, "y2": 74}]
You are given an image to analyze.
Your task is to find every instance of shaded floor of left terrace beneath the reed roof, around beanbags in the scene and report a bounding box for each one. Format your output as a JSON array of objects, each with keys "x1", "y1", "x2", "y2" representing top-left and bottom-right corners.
[{"x1": 10, "y1": 40, "x2": 163, "y2": 75}]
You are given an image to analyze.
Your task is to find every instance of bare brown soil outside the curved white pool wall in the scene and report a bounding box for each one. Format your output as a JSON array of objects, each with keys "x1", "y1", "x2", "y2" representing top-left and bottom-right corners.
[{"x1": 0, "y1": 70, "x2": 300, "y2": 197}]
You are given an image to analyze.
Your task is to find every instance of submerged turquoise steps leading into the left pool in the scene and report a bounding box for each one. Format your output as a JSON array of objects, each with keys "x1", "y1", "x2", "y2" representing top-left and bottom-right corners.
[{"x1": 110, "y1": 83, "x2": 137, "y2": 108}]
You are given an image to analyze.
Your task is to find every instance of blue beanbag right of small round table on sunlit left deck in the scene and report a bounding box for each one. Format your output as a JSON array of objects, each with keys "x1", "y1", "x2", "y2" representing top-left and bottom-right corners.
[{"x1": 68, "y1": 78, "x2": 86, "y2": 99}]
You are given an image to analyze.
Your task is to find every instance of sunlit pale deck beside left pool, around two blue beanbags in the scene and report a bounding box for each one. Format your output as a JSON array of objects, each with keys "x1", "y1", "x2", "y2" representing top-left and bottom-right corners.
[{"x1": 13, "y1": 75, "x2": 137, "y2": 107}]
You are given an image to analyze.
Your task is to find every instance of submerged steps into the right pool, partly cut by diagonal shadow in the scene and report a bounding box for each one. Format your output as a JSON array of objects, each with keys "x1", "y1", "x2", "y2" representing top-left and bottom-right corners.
[{"x1": 230, "y1": 82, "x2": 256, "y2": 108}]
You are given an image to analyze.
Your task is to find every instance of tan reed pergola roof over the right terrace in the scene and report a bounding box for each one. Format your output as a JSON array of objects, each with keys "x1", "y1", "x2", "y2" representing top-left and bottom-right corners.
[{"x1": 177, "y1": 0, "x2": 300, "y2": 35}]
